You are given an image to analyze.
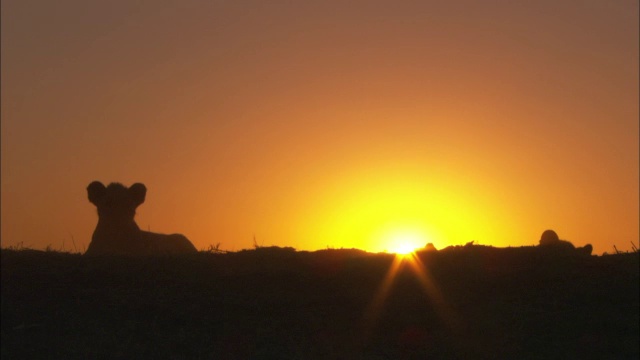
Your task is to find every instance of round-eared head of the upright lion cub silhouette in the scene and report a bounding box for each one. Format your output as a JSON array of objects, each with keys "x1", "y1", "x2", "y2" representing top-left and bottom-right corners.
[{"x1": 87, "y1": 181, "x2": 147, "y2": 223}]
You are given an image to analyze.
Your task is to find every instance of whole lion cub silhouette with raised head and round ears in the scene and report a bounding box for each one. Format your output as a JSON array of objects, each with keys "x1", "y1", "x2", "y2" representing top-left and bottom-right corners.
[{"x1": 85, "y1": 181, "x2": 197, "y2": 255}]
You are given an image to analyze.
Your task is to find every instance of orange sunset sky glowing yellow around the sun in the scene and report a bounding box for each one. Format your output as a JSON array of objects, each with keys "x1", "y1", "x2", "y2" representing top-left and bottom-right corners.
[{"x1": 1, "y1": 0, "x2": 640, "y2": 253}]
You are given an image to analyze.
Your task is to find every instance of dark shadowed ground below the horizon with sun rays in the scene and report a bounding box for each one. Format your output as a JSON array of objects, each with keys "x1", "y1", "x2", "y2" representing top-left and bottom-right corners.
[{"x1": 1, "y1": 246, "x2": 640, "y2": 359}]
